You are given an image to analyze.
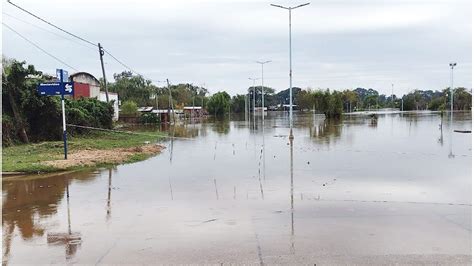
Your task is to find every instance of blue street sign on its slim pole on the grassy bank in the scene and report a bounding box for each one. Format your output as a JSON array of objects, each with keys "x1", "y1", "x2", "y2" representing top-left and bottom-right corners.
[{"x1": 38, "y1": 69, "x2": 74, "y2": 160}]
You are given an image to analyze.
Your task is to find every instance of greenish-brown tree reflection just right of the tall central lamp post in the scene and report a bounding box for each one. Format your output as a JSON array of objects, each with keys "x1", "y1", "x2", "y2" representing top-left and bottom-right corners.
[{"x1": 309, "y1": 119, "x2": 342, "y2": 144}]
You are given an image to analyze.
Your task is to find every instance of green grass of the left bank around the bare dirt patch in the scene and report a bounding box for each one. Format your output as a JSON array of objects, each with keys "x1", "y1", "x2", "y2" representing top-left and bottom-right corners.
[{"x1": 2, "y1": 131, "x2": 165, "y2": 173}]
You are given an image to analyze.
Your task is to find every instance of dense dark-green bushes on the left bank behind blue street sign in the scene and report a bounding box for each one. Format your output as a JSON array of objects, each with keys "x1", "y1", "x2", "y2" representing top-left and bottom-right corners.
[{"x1": 2, "y1": 57, "x2": 114, "y2": 146}]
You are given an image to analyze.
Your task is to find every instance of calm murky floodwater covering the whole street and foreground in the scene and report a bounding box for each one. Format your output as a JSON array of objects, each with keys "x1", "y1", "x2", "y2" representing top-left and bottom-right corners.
[{"x1": 2, "y1": 112, "x2": 472, "y2": 265}]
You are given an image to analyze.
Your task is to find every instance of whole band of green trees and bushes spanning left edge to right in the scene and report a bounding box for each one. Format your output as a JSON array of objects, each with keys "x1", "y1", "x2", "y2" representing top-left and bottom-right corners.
[{"x1": 2, "y1": 57, "x2": 472, "y2": 145}]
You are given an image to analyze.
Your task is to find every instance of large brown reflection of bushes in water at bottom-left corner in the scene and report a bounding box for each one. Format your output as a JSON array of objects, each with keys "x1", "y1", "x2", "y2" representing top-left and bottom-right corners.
[{"x1": 2, "y1": 172, "x2": 95, "y2": 264}]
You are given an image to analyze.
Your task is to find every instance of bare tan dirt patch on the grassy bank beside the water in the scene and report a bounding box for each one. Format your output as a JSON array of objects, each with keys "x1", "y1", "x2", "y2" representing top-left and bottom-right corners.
[{"x1": 42, "y1": 144, "x2": 164, "y2": 169}]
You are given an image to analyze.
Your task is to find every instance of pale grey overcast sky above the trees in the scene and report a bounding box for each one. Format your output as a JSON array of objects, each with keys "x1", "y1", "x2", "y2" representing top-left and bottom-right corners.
[{"x1": 2, "y1": 0, "x2": 472, "y2": 96}]
